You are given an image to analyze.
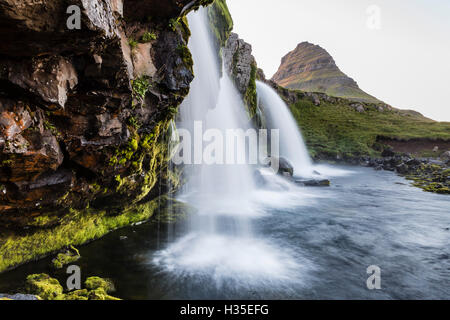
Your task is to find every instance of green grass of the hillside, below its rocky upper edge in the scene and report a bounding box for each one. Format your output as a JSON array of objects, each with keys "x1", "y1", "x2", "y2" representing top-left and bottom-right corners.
[{"x1": 290, "y1": 98, "x2": 450, "y2": 158}]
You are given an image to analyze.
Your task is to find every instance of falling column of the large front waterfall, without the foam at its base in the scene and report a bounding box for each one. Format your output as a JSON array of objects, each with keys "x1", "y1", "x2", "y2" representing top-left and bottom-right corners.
[{"x1": 178, "y1": 8, "x2": 254, "y2": 219}]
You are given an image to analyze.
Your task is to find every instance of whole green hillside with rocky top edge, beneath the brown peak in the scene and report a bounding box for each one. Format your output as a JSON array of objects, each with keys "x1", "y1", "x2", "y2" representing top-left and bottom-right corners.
[{"x1": 274, "y1": 86, "x2": 450, "y2": 160}]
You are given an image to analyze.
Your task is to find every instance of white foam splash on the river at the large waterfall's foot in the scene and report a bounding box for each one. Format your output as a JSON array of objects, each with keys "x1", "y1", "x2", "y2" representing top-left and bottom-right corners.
[{"x1": 153, "y1": 233, "x2": 309, "y2": 285}]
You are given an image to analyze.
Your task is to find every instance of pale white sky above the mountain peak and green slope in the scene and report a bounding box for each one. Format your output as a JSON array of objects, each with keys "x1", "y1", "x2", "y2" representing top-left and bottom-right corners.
[{"x1": 227, "y1": 0, "x2": 450, "y2": 121}]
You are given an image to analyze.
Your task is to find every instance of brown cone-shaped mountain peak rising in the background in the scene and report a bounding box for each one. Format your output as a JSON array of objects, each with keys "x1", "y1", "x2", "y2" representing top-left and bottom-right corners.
[{"x1": 272, "y1": 42, "x2": 380, "y2": 103}]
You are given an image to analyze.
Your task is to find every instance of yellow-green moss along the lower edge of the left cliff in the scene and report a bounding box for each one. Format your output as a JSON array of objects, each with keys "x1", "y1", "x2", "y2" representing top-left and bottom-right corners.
[{"x1": 0, "y1": 119, "x2": 179, "y2": 272}]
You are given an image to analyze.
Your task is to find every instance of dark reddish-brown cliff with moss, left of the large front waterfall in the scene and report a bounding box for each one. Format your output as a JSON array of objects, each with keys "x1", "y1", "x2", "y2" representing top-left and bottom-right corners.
[{"x1": 0, "y1": 0, "x2": 221, "y2": 272}]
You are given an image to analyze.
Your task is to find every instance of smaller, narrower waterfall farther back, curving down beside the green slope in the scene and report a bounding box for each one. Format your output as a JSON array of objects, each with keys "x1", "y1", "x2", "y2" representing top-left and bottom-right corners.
[{"x1": 256, "y1": 81, "x2": 314, "y2": 177}]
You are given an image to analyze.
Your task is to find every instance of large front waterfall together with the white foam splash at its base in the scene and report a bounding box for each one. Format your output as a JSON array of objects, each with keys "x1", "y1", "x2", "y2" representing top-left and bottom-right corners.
[{"x1": 153, "y1": 8, "x2": 299, "y2": 285}]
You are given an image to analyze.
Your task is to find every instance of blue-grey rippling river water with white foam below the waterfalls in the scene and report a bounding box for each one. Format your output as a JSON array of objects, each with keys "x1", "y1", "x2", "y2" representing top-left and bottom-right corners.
[{"x1": 0, "y1": 167, "x2": 450, "y2": 299}]
